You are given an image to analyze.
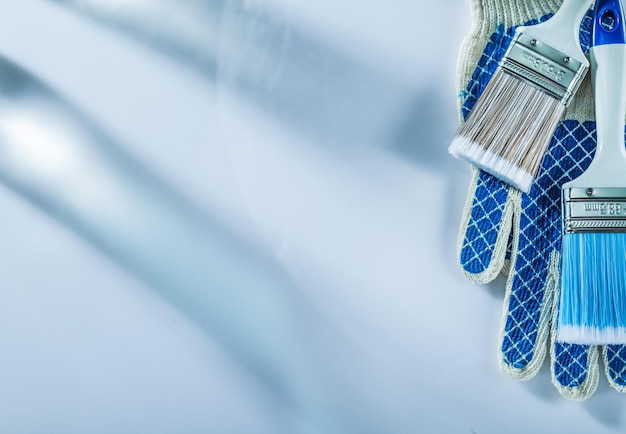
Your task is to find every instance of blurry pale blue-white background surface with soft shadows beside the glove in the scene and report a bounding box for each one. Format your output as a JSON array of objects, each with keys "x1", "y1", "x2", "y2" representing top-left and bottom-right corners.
[{"x1": 0, "y1": 0, "x2": 626, "y2": 434}]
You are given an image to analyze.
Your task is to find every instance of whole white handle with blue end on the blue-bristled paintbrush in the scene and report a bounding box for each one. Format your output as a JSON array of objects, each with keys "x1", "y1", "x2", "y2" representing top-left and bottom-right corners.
[{"x1": 564, "y1": 0, "x2": 626, "y2": 188}]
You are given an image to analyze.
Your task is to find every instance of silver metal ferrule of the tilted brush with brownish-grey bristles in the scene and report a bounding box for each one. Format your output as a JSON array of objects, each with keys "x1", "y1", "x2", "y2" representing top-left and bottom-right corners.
[{"x1": 500, "y1": 33, "x2": 589, "y2": 106}]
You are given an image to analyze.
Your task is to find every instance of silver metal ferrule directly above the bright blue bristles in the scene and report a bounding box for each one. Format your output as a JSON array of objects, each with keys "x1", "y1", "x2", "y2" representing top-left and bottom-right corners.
[{"x1": 563, "y1": 187, "x2": 626, "y2": 234}]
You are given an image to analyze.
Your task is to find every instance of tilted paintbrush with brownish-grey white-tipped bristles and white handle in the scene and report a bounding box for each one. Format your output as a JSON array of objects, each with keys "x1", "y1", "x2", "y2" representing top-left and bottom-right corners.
[{"x1": 448, "y1": 0, "x2": 592, "y2": 192}]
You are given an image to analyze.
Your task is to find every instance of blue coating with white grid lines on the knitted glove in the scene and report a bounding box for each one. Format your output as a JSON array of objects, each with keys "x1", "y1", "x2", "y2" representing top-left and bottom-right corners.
[{"x1": 460, "y1": 14, "x2": 626, "y2": 387}]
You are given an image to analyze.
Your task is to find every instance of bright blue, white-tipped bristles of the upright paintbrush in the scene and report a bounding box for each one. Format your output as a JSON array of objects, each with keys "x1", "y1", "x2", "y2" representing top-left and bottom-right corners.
[{"x1": 558, "y1": 233, "x2": 626, "y2": 344}]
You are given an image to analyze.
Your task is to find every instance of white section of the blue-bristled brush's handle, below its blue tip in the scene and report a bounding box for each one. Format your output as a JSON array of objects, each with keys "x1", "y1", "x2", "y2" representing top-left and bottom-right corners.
[{"x1": 564, "y1": 44, "x2": 626, "y2": 188}]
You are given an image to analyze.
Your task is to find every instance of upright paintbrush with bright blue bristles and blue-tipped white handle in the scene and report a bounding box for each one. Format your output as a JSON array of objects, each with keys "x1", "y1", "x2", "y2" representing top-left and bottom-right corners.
[{"x1": 557, "y1": 0, "x2": 626, "y2": 344}]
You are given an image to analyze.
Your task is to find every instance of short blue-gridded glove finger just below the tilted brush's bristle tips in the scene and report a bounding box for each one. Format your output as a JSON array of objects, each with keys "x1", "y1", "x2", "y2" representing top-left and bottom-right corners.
[{"x1": 458, "y1": 169, "x2": 514, "y2": 283}]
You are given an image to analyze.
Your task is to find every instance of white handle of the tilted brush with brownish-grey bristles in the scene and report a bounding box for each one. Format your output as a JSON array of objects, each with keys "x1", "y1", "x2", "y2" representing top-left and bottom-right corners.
[{"x1": 517, "y1": 0, "x2": 593, "y2": 65}]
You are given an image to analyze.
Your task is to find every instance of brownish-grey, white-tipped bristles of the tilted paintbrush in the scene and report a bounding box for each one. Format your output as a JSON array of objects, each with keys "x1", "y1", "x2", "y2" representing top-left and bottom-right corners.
[{"x1": 449, "y1": 70, "x2": 565, "y2": 192}]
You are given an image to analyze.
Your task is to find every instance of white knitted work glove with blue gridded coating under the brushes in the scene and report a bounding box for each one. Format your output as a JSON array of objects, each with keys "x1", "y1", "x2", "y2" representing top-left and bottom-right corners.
[{"x1": 457, "y1": 0, "x2": 626, "y2": 400}]
